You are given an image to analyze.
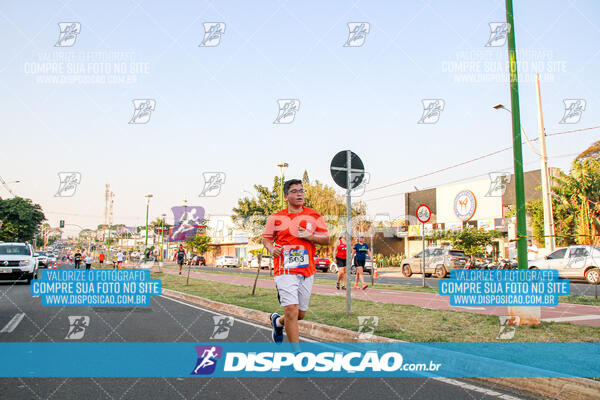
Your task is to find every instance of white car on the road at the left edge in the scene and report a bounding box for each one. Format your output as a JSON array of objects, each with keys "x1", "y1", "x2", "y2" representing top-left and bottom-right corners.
[{"x1": 0, "y1": 243, "x2": 38, "y2": 283}]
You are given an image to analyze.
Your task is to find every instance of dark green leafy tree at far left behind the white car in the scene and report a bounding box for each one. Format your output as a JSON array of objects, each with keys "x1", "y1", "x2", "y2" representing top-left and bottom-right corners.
[{"x1": 0, "y1": 197, "x2": 46, "y2": 242}]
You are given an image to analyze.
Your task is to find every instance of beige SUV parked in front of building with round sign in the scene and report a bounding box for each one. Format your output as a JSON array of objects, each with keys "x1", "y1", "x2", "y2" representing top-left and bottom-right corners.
[{"x1": 402, "y1": 247, "x2": 469, "y2": 279}]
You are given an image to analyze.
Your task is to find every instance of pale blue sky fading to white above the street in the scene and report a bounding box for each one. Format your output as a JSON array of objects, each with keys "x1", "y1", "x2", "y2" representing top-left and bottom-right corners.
[{"x1": 0, "y1": 0, "x2": 600, "y2": 234}]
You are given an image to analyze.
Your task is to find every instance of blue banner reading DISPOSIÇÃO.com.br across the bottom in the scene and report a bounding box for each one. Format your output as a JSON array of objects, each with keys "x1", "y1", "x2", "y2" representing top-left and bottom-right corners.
[{"x1": 0, "y1": 342, "x2": 600, "y2": 378}]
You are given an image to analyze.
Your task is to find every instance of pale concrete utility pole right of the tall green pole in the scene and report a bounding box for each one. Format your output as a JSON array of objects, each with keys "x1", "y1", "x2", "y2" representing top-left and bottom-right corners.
[{"x1": 535, "y1": 74, "x2": 555, "y2": 253}]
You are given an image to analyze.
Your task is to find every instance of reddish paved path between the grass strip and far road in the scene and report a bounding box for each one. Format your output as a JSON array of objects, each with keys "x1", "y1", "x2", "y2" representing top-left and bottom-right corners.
[{"x1": 152, "y1": 263, "x2": 600, "y2": 327}]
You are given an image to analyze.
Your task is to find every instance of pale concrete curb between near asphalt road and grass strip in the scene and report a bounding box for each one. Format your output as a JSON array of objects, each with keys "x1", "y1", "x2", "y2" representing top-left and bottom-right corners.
[{"x1": 162, "y1": 289, "x2": 600, "y2": 400}]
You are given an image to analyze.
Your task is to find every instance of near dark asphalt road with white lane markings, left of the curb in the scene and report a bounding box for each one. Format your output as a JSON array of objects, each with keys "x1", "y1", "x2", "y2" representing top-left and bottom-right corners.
[{"x1": 0, "y1": 264, "x2": 530, "y2": 400}]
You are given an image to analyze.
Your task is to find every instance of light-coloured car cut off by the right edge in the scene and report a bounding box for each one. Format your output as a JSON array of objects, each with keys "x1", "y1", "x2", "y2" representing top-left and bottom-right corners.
[{"x1": 529, "y1": 246, "x2": 600, "y2": 283}]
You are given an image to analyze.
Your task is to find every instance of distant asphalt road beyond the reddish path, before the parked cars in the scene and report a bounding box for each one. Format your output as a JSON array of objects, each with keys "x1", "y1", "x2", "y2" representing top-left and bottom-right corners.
[{"x1": 196, "y1": 265, "x2": 600, "y2": 296}]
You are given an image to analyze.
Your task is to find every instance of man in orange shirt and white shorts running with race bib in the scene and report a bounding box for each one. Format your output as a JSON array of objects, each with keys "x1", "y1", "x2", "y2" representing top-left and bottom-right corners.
[{"x1": 263, "y1": 179, "x2": 329, "y2": 346}]
